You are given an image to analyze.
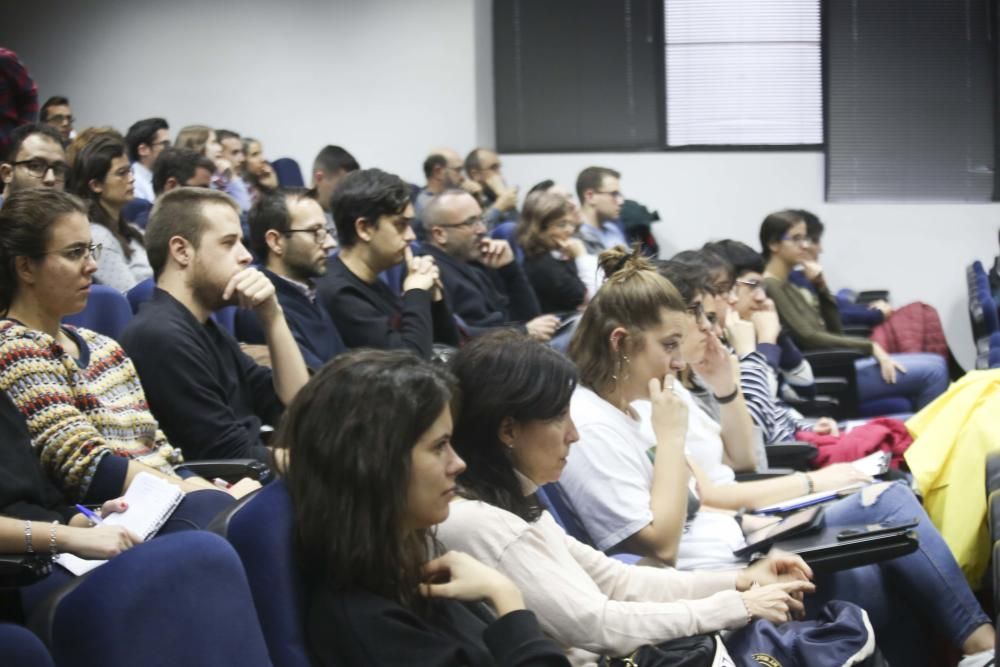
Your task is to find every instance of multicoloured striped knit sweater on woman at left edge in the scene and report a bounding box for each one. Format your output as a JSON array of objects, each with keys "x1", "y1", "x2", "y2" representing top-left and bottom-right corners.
[{"x1": 0, "y1": 320, "x2": 183, "y2": 500}]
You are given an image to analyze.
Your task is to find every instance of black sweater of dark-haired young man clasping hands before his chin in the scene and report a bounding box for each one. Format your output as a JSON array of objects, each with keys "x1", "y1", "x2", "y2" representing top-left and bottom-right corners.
[{"x1": 316, "y1": 256, "x2": 459, "y2": 359}]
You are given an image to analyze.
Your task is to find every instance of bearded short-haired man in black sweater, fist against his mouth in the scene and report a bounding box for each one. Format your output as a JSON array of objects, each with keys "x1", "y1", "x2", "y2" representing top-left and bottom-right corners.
[{"x1": 121, "y1": 188, "x2": 309, "y2": 465}]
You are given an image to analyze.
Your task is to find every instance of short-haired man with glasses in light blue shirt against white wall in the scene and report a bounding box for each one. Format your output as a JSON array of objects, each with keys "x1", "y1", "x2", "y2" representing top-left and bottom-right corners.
[{"x1": 576, "y1": 167, "x2": 628, "y2": 255}]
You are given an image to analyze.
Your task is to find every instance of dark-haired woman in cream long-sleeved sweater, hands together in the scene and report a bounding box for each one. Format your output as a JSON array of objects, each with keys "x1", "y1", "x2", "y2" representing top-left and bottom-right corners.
[{"x1": 437, "y1": 332, "x2": 812, "y2": 665}]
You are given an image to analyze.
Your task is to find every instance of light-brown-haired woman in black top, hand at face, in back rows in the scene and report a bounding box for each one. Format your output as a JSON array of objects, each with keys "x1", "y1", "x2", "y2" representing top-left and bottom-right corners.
[{"x1": 517, "y1": 192, "x2": 587, "y2": 313}]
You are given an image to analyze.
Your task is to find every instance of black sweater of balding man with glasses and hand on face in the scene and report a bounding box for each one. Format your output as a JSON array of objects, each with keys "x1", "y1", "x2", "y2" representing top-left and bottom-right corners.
[{"x1": 424, "y1": 244, "x2": 541, "y2": 336}]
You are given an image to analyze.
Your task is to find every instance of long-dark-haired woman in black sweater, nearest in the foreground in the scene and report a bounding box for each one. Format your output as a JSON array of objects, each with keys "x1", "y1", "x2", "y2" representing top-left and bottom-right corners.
[{"x1": 277, "y1": 350, "x2": 569, "y2": 667}]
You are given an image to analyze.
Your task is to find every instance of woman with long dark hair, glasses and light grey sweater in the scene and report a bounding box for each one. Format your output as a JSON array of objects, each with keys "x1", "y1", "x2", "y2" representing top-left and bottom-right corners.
[{"x1": 72, "y1": 135, "x2": 153, "y2": 292}]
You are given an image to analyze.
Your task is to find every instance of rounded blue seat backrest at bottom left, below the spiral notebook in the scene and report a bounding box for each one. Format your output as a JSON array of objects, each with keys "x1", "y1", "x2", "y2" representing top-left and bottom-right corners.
[{"x1": 42, "y1": 530, "x2": 271, "y2": 667}]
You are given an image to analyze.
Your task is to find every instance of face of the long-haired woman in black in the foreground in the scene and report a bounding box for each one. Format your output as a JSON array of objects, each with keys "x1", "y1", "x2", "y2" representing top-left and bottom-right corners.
[{"x1": 404, "y1": 406, "x2": 465, "y2": 530}]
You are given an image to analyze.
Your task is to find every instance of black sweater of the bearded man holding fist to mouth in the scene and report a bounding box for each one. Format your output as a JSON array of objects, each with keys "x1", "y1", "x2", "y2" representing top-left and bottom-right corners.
[{"x1": 121, "y1": 288, "x2": 284, "y2": 462}]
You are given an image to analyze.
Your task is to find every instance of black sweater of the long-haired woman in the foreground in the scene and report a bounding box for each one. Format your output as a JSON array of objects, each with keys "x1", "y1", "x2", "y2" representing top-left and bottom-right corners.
[{"x1": 306, "y1": 591, "x2": 569, "y2": 667}]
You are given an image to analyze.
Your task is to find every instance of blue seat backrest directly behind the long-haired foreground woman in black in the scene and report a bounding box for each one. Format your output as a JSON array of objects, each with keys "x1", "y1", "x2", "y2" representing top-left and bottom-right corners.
[{"x1": 225, "y1": 479, "x2": 309, "y2": 667}]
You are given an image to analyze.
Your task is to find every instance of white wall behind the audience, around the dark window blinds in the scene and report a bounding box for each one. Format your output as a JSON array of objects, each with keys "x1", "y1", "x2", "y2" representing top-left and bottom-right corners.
[{"x1": 0, "y1": 0, "x2": 1000, "y2": 366}]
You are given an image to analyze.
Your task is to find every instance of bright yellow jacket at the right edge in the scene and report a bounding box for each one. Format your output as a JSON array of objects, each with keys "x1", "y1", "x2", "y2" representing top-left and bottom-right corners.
[{"x1": 904, "y1": 369, "x2": 1000, "y2": 589}]
